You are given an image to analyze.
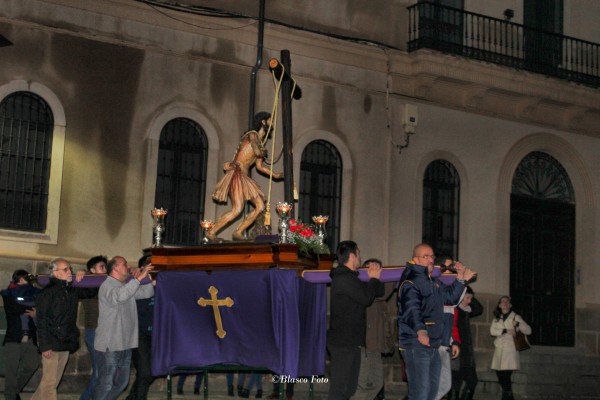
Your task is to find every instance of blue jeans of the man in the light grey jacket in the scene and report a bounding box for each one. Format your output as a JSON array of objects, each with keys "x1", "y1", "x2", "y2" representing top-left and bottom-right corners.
[{"x1": 94, "y1": 349, "x2": 131, "y2": 400}]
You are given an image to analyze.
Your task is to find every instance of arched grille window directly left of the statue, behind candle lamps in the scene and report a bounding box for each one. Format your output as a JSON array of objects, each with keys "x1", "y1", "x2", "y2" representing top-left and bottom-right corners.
[{"x1": 154, "y1": 118, "x2": 208, "y2": 245}]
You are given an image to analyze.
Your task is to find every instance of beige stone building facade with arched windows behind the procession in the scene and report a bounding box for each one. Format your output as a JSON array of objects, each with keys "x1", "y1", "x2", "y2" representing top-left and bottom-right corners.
[{"x1": 0, "y1": 0, "x2": 600, "y2": 391}]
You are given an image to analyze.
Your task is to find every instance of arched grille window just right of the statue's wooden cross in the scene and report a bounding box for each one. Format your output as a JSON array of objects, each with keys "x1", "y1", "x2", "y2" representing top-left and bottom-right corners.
[{"x1": 298, "y1": 140, "x2": 342, "y2": 252}]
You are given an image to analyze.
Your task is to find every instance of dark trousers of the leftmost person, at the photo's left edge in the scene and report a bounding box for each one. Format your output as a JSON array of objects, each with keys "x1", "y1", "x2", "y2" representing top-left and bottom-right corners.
[{"x1": 4, "y1": 341, "x2": 41, "y2": 400}]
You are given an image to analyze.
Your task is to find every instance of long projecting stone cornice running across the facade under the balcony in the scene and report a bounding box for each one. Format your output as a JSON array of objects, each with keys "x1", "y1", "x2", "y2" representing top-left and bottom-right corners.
[{"x1": 0, "y1": 0, "x2": 600, "y2": 137}]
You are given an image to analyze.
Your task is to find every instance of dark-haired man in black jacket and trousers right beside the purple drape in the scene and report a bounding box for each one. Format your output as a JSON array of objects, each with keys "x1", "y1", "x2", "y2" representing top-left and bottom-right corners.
[{"x1": 327, "y1": 240, "x2": 384, "y2": 400}]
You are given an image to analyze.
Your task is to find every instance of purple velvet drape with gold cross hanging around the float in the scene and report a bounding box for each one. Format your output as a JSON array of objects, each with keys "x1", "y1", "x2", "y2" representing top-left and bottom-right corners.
[{"x1": 152, "y1": 269, "x2": 327, "y2": 377}]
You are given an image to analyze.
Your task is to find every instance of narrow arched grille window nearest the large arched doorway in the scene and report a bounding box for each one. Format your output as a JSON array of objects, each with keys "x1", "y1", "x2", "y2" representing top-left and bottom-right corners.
[{"x1": 423, "y1": 160, "x2": 460, "y2": 259}]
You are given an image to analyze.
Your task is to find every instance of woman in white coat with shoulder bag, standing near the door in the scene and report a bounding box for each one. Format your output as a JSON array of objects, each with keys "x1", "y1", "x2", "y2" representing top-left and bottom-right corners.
[{"x1": 490, "y1": 296, "x2": 531, "y2": 400}]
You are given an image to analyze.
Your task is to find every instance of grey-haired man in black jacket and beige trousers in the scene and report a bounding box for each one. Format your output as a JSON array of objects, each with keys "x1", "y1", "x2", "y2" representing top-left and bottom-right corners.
[{"x1": 31, "y1": 258, "x2": 98, "y2": 400}]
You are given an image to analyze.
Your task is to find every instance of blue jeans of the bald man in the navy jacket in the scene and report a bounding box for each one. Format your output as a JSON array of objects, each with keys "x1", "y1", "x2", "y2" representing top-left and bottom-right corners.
[{"x1": 402, "y1": 347, "x2": 441, "y2": 400}]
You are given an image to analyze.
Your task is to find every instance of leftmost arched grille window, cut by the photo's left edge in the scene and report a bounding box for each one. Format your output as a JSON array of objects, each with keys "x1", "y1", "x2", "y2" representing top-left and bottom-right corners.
[{"x1": 0, "y1": 92, "x2": 54, "y2": 232}]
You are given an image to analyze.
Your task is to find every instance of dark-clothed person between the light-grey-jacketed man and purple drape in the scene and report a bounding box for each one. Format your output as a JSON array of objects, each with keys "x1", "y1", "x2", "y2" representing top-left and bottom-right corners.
[{"x1": 126, "y1": 255, "x2": 155, "y2": 400}]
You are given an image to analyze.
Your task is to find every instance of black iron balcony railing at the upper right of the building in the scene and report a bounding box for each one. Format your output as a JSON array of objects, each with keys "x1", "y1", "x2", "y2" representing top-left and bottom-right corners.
[{"x1": 408, "y1": 2, "x2": 600, "y2": 87}]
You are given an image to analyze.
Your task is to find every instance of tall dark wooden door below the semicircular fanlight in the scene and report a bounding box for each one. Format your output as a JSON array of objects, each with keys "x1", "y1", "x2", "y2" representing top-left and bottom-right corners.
[{"x1": 510, "y1": 194, "x2": 575, "y2": 346}]
